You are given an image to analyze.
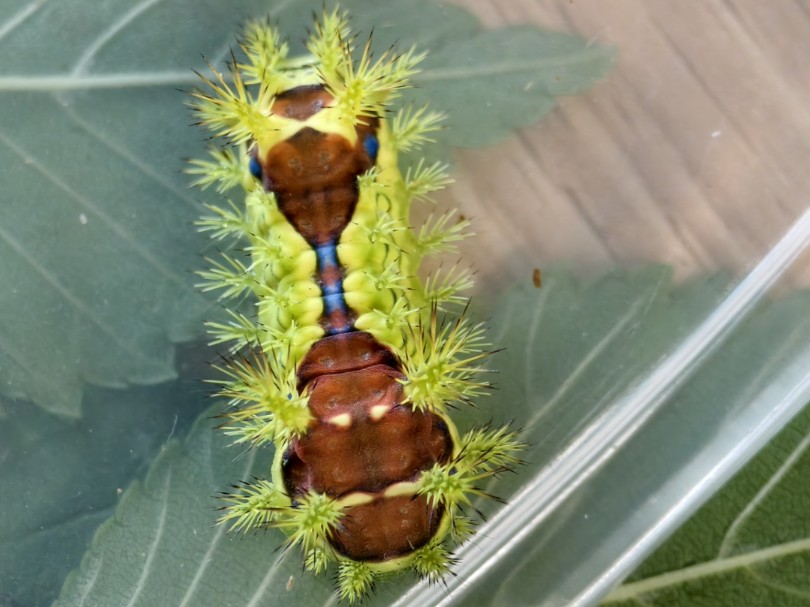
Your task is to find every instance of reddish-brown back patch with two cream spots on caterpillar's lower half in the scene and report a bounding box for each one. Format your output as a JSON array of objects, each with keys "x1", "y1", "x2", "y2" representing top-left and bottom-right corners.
[{"x1": 283, "y1": 365, "x2": 452, "y2": 497}]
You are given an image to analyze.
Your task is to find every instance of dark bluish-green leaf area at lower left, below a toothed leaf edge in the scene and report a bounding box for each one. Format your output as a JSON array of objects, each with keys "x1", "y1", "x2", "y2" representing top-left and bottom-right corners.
[{"x1": 0, "y1": 356, "x2": 202, "y2": 605}]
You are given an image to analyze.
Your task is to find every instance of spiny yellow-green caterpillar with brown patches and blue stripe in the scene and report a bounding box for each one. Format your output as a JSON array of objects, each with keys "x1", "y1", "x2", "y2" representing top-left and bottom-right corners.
[{"x1": 190, "y1": 10, "x2": 522, "y2": 601}]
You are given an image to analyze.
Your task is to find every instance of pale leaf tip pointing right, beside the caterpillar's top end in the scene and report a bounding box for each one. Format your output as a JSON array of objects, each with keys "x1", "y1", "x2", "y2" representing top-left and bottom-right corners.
[{"x1": 410, "y1": 26, "x2": 614, "y2": 147}]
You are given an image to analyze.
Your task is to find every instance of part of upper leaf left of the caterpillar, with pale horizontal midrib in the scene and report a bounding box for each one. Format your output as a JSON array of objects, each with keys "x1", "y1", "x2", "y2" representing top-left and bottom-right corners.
[{"x1": 0, "y1": 1, "x2": 237, "y2": 416}]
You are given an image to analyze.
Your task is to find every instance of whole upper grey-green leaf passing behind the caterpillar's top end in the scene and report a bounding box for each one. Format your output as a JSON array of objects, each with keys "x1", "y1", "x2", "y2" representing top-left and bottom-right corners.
[{"x1": 0, "y1": 0, "x2": 612, "y2": 416}]
